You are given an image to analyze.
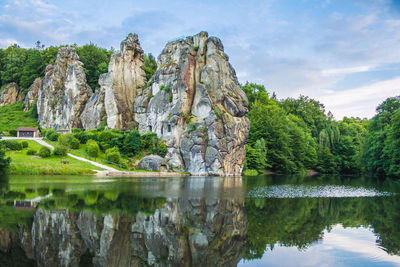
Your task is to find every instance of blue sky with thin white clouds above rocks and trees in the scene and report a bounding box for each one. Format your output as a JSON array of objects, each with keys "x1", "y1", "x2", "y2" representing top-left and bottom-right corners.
[{"x1": 0, "y1": 0, "x2": 400, "y2": 119}]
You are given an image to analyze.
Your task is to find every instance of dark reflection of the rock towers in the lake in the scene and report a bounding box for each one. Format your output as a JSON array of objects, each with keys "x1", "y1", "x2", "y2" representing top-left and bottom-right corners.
[{"x1": 10, "y1": 198, "x2": 247, "y2": 266}]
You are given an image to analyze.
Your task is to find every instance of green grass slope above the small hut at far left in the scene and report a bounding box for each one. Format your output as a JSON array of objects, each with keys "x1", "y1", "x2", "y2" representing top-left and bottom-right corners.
[{"x1": 0, "y1": 101, "x2": 37, "y2": 132}]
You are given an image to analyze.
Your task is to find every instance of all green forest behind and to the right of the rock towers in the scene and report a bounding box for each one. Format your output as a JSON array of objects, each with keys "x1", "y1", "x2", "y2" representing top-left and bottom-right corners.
[{"x1": 0, "y1": 41, "x2": 400, "y2": 177}]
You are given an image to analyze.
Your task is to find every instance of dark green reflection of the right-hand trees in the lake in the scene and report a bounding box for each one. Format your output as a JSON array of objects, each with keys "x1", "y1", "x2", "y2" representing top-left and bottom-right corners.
[{"x1": 245, "y1": 196, "x2": 400, "y2": 259}]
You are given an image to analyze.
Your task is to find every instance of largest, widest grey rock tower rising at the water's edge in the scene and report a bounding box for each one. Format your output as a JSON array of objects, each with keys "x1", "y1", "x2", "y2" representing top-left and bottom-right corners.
[{"x1": 134, "y1": 32, "x2": 250, "y2": 175}]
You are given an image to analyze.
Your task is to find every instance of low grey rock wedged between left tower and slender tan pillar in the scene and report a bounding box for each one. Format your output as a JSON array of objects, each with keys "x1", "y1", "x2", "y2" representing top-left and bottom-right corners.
[{"x1": 81, "y1": 74, "x2": 106, "y2": 130}]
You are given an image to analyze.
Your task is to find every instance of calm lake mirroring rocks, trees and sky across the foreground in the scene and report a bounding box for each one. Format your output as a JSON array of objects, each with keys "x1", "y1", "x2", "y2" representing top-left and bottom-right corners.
[{"x1": 0, "y1": 176, "x2": 400, "y2": 266}]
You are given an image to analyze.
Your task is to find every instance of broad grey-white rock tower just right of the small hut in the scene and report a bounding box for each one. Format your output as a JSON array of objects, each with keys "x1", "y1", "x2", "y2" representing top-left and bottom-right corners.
[{"x1": 37, "y1": 47, "x2": 92, "y2": 129}]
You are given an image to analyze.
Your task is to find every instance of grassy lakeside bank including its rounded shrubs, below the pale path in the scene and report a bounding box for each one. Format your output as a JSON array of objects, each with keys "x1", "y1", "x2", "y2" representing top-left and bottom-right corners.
[{"x1": 0, "y1": 140, "x2": 102, "y2": 175}]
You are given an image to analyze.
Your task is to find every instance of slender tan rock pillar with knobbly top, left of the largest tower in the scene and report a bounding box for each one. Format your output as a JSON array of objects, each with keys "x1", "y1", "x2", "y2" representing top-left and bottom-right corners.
[{"x1": 102, "y1": 34, "x2": 146, "y2": 129}]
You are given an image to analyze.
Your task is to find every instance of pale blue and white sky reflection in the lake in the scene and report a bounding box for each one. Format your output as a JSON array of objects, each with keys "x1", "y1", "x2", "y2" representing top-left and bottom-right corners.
[{"x1": 238, "y1": 225, "x2": 400, "y2": 267}]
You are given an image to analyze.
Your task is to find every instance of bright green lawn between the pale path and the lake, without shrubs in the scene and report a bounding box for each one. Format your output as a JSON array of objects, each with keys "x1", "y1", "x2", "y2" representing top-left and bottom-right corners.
[{"x1": 6, "y1": 141, "x2": 102, "y2": 175}]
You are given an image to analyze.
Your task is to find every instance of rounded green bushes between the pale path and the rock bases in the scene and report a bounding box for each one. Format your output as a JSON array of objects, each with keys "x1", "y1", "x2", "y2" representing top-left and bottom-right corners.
[{"x1": 42, "y1": 127, "x2": 167, "y2": 171}]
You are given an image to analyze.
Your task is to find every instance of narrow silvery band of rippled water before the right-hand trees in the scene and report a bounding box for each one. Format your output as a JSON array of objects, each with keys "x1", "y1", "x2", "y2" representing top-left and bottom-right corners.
[{"x1": 248, "y1": 185, "x2": 392, "y2": 198}]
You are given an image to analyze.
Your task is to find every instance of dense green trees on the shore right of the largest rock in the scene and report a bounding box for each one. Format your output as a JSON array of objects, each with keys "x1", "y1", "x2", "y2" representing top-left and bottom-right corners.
[{"x1": 242, "y1": 83, "x2": 400, "y2": 176}]
